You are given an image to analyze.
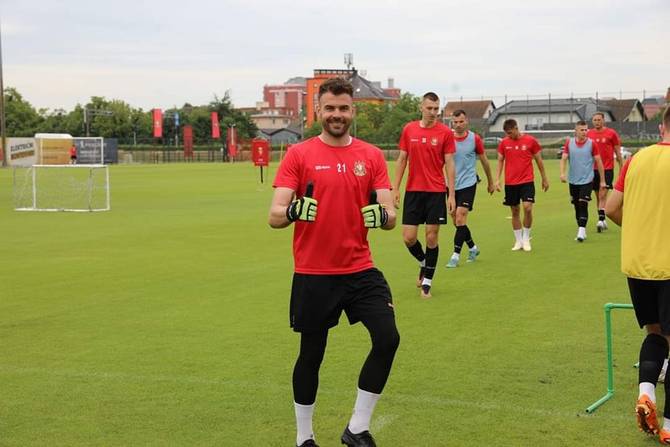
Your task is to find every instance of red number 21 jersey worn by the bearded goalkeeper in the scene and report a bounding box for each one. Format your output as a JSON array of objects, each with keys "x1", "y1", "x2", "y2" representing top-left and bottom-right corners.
[{"x1": 273, "y1": 137, "x2": 391, "y2": 275}]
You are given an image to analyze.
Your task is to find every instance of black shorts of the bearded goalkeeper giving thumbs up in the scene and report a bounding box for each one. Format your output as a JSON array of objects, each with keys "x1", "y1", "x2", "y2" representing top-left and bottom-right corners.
[{"x1": 289, "y1": 268, "x2": 394, "y2": 332}]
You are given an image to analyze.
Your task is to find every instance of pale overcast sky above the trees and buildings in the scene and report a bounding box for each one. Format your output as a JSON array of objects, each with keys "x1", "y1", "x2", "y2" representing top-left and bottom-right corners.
[{"x1": 0, "y1": 0, "x2": 670, "y2": 110}]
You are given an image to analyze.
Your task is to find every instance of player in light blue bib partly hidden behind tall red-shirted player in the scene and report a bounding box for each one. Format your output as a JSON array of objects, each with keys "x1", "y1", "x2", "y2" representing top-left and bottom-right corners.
[{"x1": 447, "y1": 109, "x2": 495, "y2": 268}]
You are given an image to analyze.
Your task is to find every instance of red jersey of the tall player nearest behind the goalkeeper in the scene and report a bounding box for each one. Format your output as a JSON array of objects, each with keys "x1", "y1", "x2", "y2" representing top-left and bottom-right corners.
[{"x1": 398, "y1": 121, "x2": 456, "y2": 192}]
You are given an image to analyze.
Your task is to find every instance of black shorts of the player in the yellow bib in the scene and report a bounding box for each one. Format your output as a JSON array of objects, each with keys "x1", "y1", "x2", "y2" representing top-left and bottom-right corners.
[{"x1": 628, "y1": 278, "x2": 670, "y2": 335}]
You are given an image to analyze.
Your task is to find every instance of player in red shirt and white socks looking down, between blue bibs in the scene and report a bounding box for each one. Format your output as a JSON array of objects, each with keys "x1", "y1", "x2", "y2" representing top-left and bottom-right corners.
[{"x1": 495, "y1": 119, "x2": 549, "y2": 251}]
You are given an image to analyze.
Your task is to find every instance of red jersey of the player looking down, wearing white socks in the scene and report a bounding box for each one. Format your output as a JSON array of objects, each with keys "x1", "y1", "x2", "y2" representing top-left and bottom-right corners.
[{"x1": 498, "y1": 134, "x2": 542, "y2": 185}]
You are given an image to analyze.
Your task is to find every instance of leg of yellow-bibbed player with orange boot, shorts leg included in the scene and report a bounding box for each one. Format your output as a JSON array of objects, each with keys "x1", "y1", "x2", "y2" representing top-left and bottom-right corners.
[{"x1": 628, "y1": 278, "x2": 668, "y2": 433}]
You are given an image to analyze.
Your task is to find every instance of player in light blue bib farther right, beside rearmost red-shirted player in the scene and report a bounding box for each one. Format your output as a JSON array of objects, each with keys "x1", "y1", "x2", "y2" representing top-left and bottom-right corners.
[{"x1": 561, "y1": 121, "x2": 606, "y2": 242}]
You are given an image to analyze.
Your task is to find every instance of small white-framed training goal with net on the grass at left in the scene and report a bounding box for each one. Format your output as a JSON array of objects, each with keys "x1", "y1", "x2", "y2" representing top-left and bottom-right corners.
[{"x1": 13, "y1": 164, "x2": 110, "y2": 211}]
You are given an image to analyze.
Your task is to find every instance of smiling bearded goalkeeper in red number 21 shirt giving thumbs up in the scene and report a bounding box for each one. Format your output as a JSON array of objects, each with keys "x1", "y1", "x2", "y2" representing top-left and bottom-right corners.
[{"x1": 269, "y1": 78, "x2": 400, "y2": 447}]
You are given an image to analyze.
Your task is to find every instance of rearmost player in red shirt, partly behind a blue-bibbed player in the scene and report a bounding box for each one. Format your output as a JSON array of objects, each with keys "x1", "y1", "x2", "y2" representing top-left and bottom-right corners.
[{"x1": 586, "y1": 112, "x2": 623, "y2": 233}]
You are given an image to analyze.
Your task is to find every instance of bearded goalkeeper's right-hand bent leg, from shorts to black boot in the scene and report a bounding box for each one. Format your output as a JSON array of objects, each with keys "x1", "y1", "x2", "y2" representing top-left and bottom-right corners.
[{"x1": 342, "y1": 269, "x2": 400, "y2": 446}]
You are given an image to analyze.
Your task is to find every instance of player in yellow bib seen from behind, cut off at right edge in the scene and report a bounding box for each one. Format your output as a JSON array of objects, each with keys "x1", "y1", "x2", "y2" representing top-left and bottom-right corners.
[{"x1": 606, "y1": 107, "x2": 670, "y2": 444}]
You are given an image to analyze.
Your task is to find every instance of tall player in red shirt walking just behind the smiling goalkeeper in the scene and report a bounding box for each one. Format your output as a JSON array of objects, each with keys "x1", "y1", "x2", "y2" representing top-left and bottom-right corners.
[{"x1": 393, "y1": 92, "x2": 456, "y2": 298}]
